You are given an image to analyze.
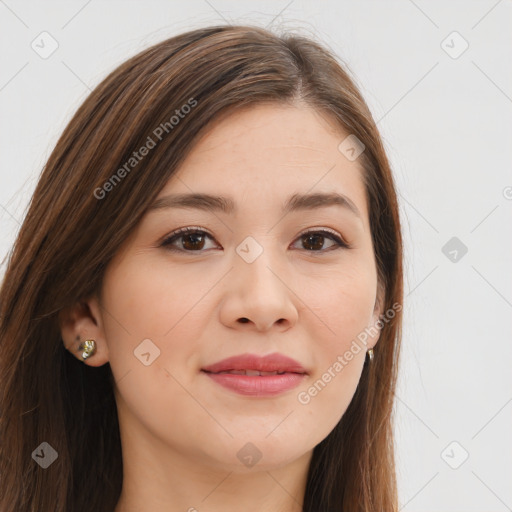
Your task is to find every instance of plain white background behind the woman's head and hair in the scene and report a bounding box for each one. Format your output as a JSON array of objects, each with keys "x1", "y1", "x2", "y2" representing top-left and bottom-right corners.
[{"x1": 0, "y1": 0, "x2": 512, "y2": 512}]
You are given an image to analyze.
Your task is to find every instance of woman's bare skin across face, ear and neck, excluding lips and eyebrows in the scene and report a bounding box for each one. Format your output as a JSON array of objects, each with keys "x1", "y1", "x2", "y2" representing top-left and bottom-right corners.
[{"x1": 61, "y1": 104, "x2": 383, "y2": 512}]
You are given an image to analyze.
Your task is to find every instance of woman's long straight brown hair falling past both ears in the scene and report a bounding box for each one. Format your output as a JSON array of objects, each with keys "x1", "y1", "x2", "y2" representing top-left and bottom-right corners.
[{"x1": 0, "y1": 26, "x2": 403, "y2": 512}]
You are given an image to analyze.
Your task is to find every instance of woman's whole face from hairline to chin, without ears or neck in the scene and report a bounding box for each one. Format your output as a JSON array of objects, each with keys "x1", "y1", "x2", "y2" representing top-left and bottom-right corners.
[{"x1": 94, "y1": 105, "x2": 381, "y2": 472}]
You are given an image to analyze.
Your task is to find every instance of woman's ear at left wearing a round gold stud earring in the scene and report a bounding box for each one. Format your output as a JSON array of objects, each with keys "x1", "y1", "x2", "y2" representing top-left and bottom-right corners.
[{"x1": 59, "y1": 297, "x2": 109, "y2": 366}]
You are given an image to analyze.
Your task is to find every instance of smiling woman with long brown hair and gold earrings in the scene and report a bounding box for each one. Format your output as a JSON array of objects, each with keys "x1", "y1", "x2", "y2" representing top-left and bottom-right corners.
[{"x1": 0, "y1": 26, "x2": 402, "y2": 512}]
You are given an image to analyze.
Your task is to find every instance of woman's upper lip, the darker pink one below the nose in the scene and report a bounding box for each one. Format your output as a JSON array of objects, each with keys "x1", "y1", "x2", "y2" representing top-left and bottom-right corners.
[{"x1": 202, "y1": 353, "x2": 307, "y2": 374}]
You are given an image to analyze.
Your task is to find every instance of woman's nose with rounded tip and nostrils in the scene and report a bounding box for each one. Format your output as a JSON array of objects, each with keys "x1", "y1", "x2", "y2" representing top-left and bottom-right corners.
[{"x1": 220, "y1": 245, "x2": 298, "y2": 331}]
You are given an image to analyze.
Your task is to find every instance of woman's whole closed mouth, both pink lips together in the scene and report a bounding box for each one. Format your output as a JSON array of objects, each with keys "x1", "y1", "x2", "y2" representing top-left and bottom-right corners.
[{"x1": 201, "y1": 353, "x2": 308, "y2": 397}]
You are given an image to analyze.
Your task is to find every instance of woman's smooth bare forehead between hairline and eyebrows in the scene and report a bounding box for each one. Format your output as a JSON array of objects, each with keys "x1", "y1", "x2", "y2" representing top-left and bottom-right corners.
[{"x1": 161, "y1": 104, "x2": 367, "y2": 221}]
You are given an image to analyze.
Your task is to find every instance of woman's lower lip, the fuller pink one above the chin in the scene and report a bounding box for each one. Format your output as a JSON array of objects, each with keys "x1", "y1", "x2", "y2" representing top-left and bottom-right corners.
[{"x1": 203, "y1": 372, "x2": 306, "y2": 396}]
